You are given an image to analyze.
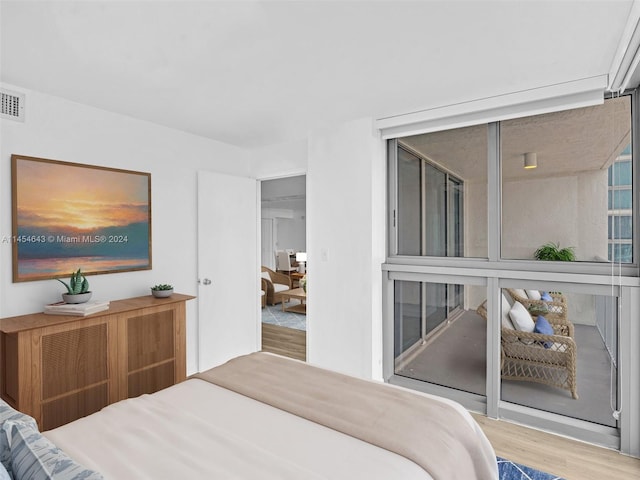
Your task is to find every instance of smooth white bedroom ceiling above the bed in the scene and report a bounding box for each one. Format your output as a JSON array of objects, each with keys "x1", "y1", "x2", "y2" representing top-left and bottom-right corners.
[{"x1": 0, "y1": 0, "x2": 633, "y2": 147}]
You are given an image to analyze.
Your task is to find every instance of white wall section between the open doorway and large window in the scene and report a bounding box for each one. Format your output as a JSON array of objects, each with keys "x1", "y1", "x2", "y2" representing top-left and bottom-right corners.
[{"x1": 307, "y1": 118, "x2": 386, "y2": 378}]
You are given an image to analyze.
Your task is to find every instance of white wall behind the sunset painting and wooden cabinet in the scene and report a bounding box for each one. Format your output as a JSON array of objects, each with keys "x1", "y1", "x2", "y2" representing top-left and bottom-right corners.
[{"x1": 0, "y1": 85, "x2": 250, "y2": 373}]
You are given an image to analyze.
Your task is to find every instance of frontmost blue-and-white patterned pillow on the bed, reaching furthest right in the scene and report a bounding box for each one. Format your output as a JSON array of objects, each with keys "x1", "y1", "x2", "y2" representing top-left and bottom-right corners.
[{"x1": 2, "y1": 420, "x2": 103, "y2": 480}]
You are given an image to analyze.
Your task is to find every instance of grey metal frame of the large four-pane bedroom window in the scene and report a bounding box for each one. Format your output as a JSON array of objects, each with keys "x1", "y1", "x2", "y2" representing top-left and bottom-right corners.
[{"x1": 378, "y1": 90, "x2": 640, "y2": 456}]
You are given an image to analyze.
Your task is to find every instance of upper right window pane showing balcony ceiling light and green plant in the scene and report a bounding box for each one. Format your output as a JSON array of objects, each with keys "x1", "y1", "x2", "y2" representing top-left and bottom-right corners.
[{"x1": 500, "y1": 96, "x2": 633, "y2": 262}]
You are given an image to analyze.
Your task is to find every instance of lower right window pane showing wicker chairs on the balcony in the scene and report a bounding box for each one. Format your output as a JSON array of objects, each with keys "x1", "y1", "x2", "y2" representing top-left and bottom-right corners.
[{"x1": 499, "y1": 289, "x2": 618, "y2": 427}]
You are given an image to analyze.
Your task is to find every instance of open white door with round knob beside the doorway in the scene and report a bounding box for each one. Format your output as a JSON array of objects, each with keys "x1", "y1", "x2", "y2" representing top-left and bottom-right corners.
[{"x1": 198, "y1": 171, "x2": 260, "y2": 371}]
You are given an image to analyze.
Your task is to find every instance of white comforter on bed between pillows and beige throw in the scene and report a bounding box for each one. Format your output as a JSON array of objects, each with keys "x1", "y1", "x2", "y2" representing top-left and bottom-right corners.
[{"x1": 44, "y1": 379, "x2": 431, "y2": 480}]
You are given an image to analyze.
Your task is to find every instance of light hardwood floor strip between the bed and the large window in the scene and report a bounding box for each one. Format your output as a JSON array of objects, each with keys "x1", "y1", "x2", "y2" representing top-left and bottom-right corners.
[{"x1": 473, "y1": 414, "x2": 640, "y2": 480}]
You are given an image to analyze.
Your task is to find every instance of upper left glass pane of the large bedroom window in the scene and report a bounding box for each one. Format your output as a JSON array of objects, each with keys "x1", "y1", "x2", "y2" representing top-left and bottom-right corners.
[{"x1": 398, "y1": 125, "x2": 488, "y2": 258}]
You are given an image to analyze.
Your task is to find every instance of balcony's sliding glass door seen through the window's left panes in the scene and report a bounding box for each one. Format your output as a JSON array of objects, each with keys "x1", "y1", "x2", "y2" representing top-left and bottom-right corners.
[{"x1": 394, "y1": 146, "x2": 464, "y2": 382}]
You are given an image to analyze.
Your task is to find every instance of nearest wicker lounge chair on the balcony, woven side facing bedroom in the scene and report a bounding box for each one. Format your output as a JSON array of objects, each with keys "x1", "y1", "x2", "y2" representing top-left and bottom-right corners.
[{"x1": 476, "y1": 300, "x2": 578, "y2": 399}]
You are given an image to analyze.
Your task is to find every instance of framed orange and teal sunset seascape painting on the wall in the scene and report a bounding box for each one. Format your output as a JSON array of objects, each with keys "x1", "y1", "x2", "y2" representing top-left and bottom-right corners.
[{"x1": 11, "y1": 155, "x2": 151, "y2": 282}]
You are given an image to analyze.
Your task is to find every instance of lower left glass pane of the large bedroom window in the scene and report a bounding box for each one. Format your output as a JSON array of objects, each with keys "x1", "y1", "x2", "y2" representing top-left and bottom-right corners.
[{"x1": 394, "y1": 281, "x2": 487, "y2": 395}]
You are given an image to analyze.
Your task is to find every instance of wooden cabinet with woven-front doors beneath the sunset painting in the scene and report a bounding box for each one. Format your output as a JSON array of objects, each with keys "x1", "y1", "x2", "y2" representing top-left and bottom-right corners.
[{"x1": 0, "y1": 294, "x2": 195, "y2": 430}]
